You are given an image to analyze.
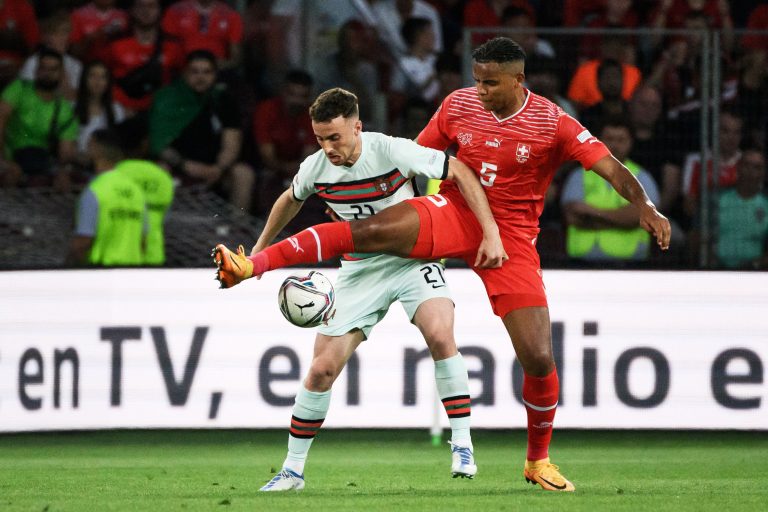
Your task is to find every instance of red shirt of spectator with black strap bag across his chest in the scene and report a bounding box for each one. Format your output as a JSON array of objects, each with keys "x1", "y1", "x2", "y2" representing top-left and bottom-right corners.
[{"x1": 108, "y1": 35, "x2": 184, "y2": 112}]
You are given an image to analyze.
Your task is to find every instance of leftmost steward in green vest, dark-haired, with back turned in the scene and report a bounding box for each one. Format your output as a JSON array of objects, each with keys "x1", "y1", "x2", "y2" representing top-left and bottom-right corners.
[{"x1": 67, "y1": 130, "x2": 148, "y2": 267}]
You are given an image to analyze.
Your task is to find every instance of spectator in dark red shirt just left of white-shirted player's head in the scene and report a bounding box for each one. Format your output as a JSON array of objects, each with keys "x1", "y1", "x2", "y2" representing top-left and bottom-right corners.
[{"x1": 253, "y1": 70, "x2": 317, "y2": 213}]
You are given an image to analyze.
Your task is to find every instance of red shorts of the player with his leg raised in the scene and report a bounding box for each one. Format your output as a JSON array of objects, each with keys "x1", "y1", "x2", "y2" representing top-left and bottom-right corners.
[{"x1": 408, "y1": 194, "x2": 547, "y2": 317}]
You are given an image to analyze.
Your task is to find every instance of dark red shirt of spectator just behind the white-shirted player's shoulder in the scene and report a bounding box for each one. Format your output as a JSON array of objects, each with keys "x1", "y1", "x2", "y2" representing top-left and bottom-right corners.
[{"x1": 253, "y1": 96, "x2": 316, "y2": 161}]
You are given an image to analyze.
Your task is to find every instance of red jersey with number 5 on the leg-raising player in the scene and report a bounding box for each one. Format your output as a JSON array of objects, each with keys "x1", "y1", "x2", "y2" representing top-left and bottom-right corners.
[{"x1": 417, "y1": 87, "x2": 610, "y2": 228}]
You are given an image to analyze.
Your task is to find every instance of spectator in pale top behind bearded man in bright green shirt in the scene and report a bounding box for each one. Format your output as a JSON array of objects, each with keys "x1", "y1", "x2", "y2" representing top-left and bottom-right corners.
[{"x1": 19, "y1": 12, "x2": 83, "y2": 101}]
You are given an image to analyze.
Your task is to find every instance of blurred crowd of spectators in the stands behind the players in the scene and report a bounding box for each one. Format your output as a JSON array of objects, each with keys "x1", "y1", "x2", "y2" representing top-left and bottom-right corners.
[{"x1": 0, "y1": 0, "x2": 768, "y2": 268}]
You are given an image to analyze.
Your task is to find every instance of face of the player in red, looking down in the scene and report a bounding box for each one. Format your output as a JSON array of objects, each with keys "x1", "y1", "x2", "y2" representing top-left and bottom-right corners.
[{"x1": 472, "y1": 62, "x2": 525, "y2": 114}]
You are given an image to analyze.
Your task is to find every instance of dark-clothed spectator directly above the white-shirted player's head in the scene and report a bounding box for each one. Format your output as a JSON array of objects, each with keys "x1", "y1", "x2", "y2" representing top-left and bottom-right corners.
[{"x1": 315, "y1": 20, "x2": 384, "y2": 131}]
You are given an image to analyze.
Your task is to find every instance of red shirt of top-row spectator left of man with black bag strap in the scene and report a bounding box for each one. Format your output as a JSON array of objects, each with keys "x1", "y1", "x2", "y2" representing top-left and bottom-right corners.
[{"x1": 70, "y1": 3, "x2": 128, "y2": 60}]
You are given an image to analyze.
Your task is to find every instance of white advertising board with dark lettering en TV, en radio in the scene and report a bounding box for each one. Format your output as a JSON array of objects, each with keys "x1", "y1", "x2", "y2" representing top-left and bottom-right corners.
[{"x1": 0, "y1": 269, "x2": 768, "y2": 431}]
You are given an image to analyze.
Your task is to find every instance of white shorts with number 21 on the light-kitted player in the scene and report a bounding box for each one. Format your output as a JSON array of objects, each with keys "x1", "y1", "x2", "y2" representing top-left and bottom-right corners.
[{"x1": 318, "y1": 255, "x2": 451, "y2": 339}]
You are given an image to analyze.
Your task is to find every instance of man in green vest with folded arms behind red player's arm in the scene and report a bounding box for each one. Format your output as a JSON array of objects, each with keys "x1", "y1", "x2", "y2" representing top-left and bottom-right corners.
[{"x1": 560, "y1": 120, "x2": 659, "y2": 262}]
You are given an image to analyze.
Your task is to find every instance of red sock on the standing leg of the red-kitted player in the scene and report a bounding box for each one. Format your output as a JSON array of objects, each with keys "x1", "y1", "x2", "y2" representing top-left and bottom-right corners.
[{"x1": 523, "y1": 370, "x2": 560, "y2": 460}]
